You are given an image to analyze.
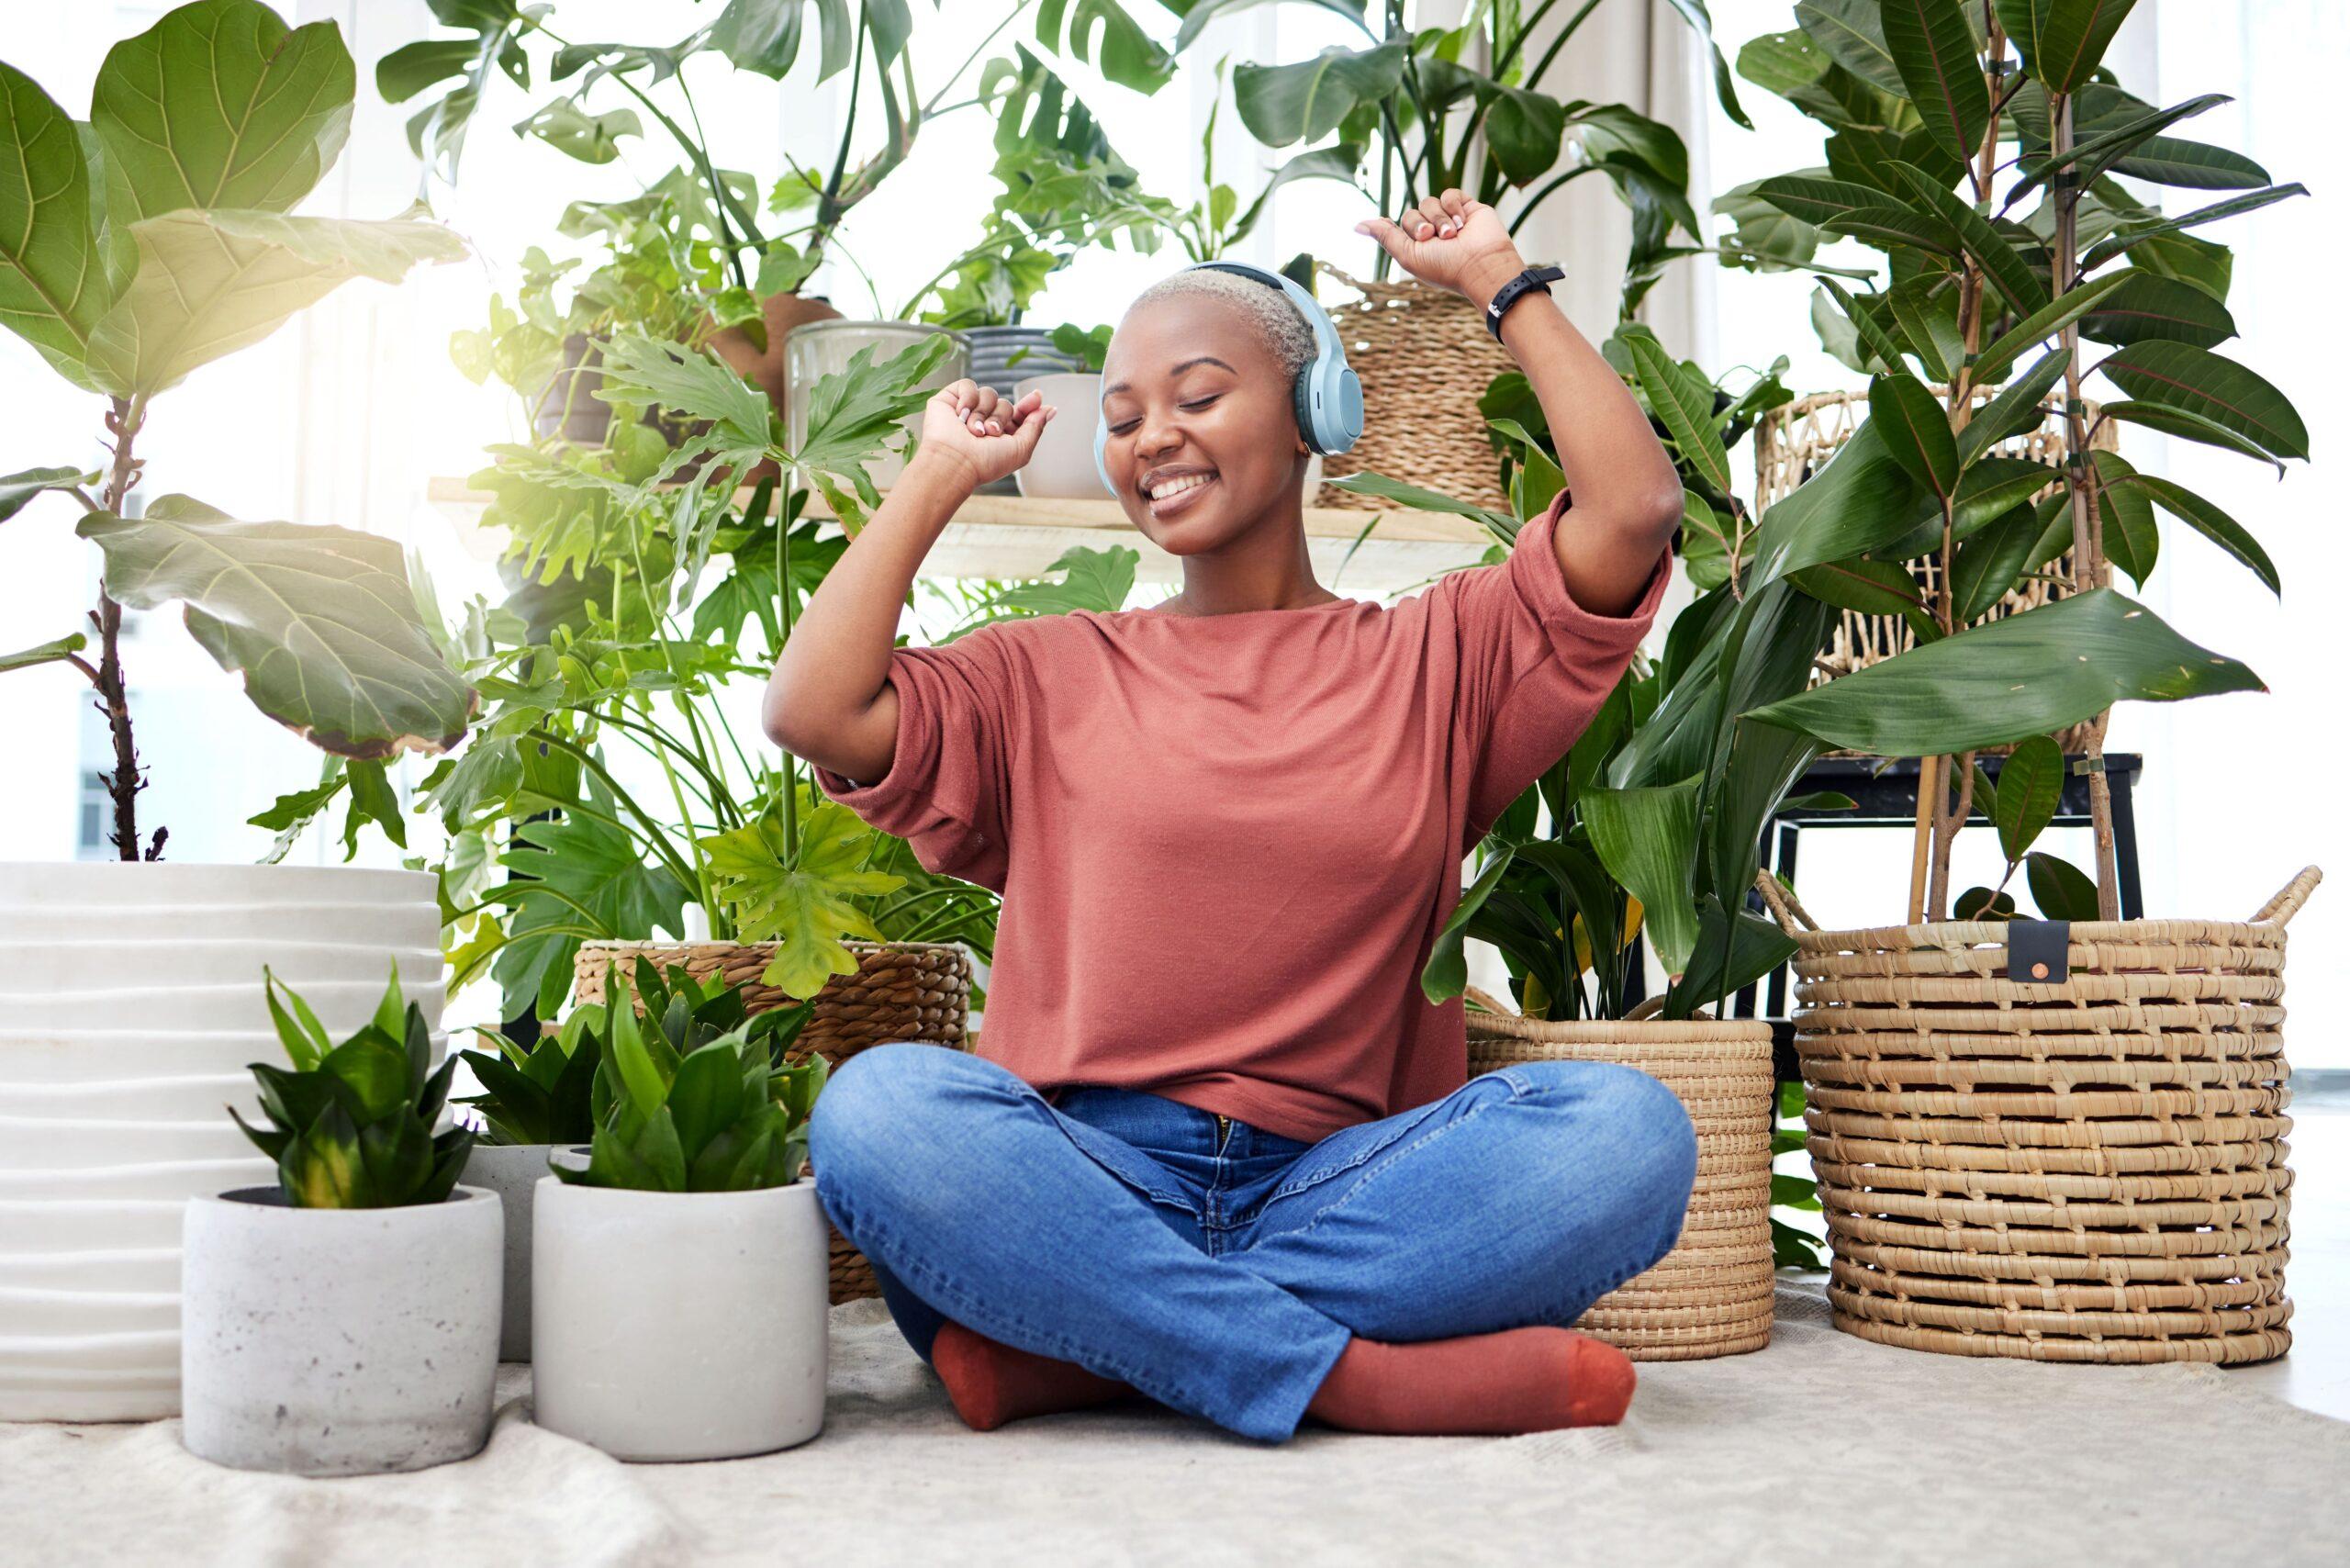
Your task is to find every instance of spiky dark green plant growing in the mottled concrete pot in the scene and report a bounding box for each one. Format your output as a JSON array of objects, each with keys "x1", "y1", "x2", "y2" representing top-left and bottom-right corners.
[{"x1": 228, "y1": 964, "x2": 475, "y2": 1208}]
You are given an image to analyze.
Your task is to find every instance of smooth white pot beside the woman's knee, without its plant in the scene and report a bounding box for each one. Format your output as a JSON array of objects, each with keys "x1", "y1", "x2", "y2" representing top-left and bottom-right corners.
[{"x1": 532, "y1": 1175, "x2": 832, "y2": 1460}]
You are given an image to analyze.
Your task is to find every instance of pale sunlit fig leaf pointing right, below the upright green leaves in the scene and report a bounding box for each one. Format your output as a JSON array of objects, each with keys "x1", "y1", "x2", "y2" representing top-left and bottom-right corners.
[{"x1": 89, "y1": 211, "x2": 465, "y2": 395}]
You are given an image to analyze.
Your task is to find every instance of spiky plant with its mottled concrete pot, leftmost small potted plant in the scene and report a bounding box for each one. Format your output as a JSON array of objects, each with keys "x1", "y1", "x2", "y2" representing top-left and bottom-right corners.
[{"x1": 181, "y1": 969, "x2": 503, "y2": 1476}]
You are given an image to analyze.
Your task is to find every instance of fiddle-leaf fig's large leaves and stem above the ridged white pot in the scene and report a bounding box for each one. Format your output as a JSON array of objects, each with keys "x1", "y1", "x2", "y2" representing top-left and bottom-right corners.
[{"x1": 0, "y1": 0, "x2": 477, "y2": 860}]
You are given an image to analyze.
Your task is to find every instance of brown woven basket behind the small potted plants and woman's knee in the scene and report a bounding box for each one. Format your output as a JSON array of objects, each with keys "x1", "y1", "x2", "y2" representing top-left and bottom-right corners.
[{"x1": 571, "y1": 940, "x2": 970, "y2": 1305}]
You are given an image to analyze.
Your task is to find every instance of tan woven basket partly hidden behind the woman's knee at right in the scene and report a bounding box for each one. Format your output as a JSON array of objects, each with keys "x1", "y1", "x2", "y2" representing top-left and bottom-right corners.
[{"x1": 1466, "y1": 985, "x2": 1776, "y2": 1361}]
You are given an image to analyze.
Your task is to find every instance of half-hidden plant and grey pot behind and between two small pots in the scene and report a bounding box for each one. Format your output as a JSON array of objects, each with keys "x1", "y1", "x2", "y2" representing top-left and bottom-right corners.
[{"x1": 456, "y1": 1009, "x2": 604, "y2": 1361}]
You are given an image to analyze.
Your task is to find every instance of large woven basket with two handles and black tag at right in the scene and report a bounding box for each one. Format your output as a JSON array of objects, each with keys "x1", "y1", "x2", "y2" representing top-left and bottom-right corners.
[{"x1": 1755, "y1": 865, "x2": 2320, "y2": 1363}]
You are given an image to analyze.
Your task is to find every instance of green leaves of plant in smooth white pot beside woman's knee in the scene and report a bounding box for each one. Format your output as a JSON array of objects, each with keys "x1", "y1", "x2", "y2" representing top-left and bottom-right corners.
[{"x1": 554, "y1": 959, "x2": 827, "y2": 1192}]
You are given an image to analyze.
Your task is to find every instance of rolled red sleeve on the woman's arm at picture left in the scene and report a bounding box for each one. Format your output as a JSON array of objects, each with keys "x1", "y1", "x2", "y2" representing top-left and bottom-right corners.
[{"x1": 811, "y1": 623, "x2": 1024, "y2": 893}]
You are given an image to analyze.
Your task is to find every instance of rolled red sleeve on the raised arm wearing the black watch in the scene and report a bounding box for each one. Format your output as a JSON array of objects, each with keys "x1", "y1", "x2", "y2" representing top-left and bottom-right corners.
[{"x1": 1443, "y1": 491, "x2": 1673, "y2": 844}]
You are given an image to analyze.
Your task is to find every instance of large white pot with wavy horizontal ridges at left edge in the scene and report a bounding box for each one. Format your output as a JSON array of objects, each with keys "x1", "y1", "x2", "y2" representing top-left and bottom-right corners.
[{"x1": 0, "y1": 860, "x2": 444, "y2": 1420}]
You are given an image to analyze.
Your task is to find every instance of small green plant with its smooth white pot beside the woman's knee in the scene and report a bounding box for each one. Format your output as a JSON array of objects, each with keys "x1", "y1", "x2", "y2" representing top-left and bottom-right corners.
[{"x1": 532, "y1": 961, "x2": 830, "y2": 1460}]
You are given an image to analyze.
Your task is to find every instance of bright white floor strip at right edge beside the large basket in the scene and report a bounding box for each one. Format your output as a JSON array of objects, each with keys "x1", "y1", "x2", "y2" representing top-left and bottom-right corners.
[{"x1": 2228, "y1": 1095, "x2": 2350, "y2": 1420}]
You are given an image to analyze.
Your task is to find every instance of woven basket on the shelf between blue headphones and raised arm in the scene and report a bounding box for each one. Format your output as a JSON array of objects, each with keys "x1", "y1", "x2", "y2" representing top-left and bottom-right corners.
[{"x1": 1314, "y1": 261, "x2": 1518, "y2": 512}]
